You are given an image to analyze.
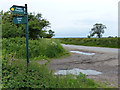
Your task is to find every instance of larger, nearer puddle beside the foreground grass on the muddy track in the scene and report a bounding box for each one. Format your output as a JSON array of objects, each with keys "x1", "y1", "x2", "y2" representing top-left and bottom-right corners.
[{"x1": 54, "y1": 68, "x2": 102, "y2": 75}]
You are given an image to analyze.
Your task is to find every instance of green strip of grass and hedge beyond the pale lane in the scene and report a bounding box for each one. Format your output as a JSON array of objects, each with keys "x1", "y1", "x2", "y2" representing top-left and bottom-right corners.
[{"x1": 59, "y1": 38, "x2": 120, "y2": 48}]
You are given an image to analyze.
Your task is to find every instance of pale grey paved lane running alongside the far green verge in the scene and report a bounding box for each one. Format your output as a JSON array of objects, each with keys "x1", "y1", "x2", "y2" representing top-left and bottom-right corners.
[{"x1": 62, "y1": 44, "x2": 120, "y2": 54}]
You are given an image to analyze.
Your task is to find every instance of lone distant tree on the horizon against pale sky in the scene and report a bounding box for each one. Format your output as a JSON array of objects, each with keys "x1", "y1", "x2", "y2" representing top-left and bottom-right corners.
[{"x1": 88, "y1": 23, "x2": 107, "y2": 38}]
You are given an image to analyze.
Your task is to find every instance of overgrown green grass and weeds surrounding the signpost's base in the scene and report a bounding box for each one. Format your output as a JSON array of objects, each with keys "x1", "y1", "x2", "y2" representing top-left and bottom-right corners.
[{"x1": 2, "y1": 38, "x2": 109, "y2": 89}]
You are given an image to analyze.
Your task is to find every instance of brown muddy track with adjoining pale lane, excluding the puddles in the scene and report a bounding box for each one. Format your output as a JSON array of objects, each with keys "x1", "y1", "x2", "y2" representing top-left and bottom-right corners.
[{"x1": 48, "y1": 44, "x2": 118, "y2": 87}]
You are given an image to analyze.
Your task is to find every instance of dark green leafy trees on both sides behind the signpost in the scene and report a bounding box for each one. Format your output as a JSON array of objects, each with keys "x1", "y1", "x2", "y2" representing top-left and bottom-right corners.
[{"x1": 0, "y1": 11, "x2": 54, "y2": 39}]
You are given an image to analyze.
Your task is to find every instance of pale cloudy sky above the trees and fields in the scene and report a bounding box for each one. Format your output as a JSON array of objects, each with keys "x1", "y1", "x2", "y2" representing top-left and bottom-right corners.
[{"x1": 0, "y1": 0, "x2": 119, "y2": 37}]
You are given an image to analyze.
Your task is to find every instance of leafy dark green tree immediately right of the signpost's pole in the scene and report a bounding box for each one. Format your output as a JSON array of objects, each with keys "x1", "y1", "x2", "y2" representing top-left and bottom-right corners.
[{"x1": 29, "y1": 13, "x2": 50, "y2": 39}]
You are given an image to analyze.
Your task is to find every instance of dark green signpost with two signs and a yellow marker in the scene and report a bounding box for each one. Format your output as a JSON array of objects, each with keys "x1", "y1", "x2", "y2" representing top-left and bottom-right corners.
[{"x1": 10, "y1": 4, "x2": 29, "y2": 66}]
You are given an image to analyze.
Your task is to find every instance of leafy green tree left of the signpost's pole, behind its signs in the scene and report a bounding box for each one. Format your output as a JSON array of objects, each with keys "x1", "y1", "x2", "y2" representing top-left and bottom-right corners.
[{"x1": 1, "y1": 11, "x2": 24, "y2": 38}]
